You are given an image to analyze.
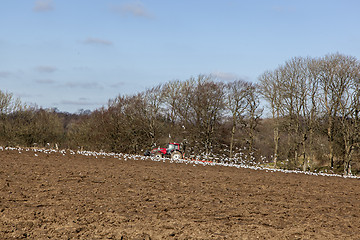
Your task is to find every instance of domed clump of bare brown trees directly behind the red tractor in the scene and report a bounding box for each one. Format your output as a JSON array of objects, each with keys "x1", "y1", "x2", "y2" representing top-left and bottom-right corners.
[{"x1": 69, "y1": 75, "x2": 261, "y2": 157}]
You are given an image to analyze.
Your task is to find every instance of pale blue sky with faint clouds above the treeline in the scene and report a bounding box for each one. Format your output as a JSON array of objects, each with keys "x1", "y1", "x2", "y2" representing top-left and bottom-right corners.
[{"x1": 0, "y1": 0, "x2": 360, "y2": 113}]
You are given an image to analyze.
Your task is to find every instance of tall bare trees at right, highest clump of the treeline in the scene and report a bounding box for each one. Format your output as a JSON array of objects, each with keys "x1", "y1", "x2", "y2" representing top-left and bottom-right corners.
[{"x1": 259, "y1": 54, "x2": 360, "y2": 174}]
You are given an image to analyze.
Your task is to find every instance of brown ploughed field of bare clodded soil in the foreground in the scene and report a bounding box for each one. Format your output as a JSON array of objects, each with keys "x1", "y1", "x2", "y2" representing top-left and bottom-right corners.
[{"x1": 0, "y1": 149, "x2": 360, "y2": 239}]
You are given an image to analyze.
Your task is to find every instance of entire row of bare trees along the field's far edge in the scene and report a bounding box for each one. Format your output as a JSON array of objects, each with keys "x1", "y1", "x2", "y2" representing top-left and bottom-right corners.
[{"x1": 0, "y1": 54, "x2": 360, "y2": 174}]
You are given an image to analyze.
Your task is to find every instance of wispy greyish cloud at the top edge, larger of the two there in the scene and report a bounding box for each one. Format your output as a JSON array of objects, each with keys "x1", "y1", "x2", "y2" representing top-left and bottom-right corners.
[{"x1": 111, "y1": 1, "x2": 154, "y2": 19}]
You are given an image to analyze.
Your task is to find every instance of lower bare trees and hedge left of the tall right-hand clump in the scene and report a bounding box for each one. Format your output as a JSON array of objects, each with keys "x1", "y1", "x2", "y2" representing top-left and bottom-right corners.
[{"x1": 0, "y1": 75, "x2": 262, "y2": 158}]
